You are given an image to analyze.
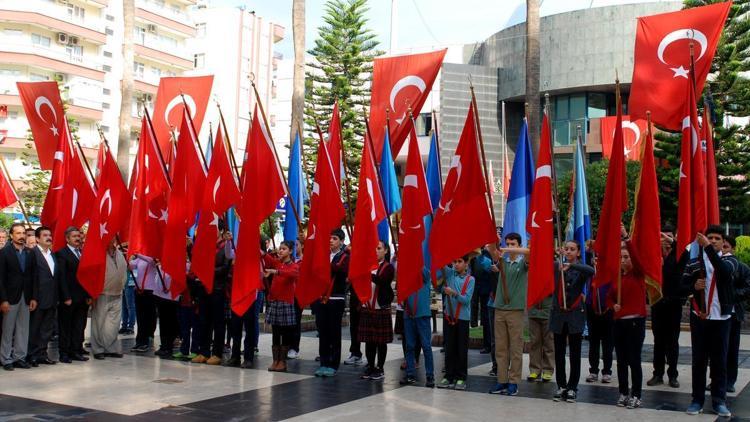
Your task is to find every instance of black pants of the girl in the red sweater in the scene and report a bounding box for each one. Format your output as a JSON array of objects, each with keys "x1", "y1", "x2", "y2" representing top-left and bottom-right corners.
[{"x1": 615, "y1": 318, "x2": 646, "y2": 398}]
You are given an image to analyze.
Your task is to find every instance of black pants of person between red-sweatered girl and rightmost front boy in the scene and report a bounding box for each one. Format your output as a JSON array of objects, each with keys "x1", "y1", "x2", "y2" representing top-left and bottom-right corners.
[{"x1": 651, "y1": 298, "x2": 684, "y2": 379}]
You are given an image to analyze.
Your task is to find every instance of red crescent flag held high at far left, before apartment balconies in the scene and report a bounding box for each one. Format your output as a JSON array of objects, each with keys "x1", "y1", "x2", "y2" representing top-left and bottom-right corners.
[{"x1": 16, "y1": 81, "x2": 66, "y2": 170}]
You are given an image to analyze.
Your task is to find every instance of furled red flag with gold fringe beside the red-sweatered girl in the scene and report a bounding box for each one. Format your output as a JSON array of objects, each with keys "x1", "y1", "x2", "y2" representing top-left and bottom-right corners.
[{"x1": 630, "y1": 123, "x2": 662, "y2": 303}]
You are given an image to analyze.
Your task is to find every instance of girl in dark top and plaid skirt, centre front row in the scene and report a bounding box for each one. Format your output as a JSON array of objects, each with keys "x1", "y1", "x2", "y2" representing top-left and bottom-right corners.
[{"x1": 360, "y1": 241, "x2": 396, "y2": 381}]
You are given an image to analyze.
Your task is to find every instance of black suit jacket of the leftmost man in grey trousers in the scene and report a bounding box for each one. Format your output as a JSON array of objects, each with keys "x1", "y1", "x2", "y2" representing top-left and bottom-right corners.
[{"x1": 0, "y1": 242, "x2": 38, "y2": 305}]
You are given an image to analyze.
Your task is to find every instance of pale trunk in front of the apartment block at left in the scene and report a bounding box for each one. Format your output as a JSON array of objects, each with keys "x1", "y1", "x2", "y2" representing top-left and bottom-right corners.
[{"x1": 117, "y1": 0, "x2": 135, "y2": 180}]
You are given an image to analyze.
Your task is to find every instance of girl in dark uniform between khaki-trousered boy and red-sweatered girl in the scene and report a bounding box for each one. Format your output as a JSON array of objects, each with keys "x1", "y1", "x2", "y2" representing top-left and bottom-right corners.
[{"x1": 549, "y1": 240, "x2": 594, "y2": 403}]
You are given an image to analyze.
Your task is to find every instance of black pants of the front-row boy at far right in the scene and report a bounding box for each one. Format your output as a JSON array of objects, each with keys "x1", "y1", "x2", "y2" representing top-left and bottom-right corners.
[{"x1": 690, "y1": 312, "x2": 731, "y2": 405}]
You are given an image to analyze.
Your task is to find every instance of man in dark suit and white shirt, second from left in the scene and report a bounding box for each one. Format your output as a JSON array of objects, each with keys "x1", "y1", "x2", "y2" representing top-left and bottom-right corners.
[{"x1": 27, "y1": 226, "x2": 68, "y2": 367}]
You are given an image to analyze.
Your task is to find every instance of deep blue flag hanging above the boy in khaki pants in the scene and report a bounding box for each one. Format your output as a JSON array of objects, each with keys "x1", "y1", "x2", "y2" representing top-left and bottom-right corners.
[{"x1": 503, "y1": 119, "x2": 536, "y2": 246}]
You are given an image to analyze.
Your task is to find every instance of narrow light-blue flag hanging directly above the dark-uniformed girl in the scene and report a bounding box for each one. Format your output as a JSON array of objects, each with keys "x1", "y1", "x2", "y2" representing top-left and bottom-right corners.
[{"x1": 565, "y1": 134, "x2": 591, "y2": 263}]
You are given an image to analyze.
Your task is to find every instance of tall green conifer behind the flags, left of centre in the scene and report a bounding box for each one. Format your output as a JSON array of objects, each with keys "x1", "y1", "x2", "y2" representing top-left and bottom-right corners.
[{"x1": 304, "y1": 0, "x2": 382, "y2": 191}]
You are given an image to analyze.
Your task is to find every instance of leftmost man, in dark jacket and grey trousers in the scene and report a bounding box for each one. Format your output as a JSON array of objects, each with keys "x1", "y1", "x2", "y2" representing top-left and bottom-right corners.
[{"x1": 0, "y1": 223, "x2": 38, "y2": 371}]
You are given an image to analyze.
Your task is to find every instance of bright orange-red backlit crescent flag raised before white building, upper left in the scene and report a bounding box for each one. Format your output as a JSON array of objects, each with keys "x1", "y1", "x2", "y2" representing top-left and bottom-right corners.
[{"x1": 153, "y1": 75, "x2": 214, "y2": 157}]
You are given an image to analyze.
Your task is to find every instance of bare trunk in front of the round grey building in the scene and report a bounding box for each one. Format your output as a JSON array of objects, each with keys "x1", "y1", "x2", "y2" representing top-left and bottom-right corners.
[{"x1": 526, "y1": 0, "x2": 542, "y2": 153}]
